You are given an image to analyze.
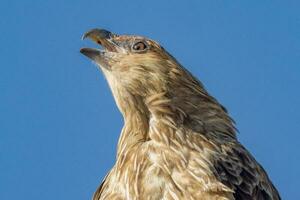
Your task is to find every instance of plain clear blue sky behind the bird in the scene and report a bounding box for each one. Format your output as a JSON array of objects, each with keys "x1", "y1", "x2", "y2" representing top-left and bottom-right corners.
[{"x1": 0, "y1": 0, "x2": 300, "y2": 200}]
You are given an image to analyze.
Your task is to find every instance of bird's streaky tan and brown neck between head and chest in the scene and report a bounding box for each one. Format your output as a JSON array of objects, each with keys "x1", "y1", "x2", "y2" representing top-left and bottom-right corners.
[{"x1": 115, "y1": 86, "x2": 235, "y2": 157}]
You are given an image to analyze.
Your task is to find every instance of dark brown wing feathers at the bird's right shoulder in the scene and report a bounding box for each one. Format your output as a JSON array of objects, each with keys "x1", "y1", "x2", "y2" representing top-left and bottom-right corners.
[{"x1": 213, "y1": 141, "x2": 280, "y2": 200}]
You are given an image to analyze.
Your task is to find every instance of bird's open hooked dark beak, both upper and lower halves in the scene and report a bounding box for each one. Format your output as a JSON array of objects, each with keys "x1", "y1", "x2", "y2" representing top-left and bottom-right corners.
[{"x1": 80, "y1": 29, "x2": 118, "y2": 62}]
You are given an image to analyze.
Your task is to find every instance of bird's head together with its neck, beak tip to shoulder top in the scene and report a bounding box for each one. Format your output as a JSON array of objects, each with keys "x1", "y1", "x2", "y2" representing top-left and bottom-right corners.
[{"x1": 80, "y1": 29, "x2": 234, "y2": 138}]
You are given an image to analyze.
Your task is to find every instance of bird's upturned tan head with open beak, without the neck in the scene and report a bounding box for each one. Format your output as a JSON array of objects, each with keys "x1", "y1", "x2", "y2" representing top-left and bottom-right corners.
[{"x1": 80, "y1": 29, "x2": 188, "y2": 115}]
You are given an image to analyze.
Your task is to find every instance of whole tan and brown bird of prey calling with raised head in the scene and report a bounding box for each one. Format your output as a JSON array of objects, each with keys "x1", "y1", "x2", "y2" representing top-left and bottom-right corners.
[{"x1": 80, "y1": 29, "x2": 280, "y2": 200}]
